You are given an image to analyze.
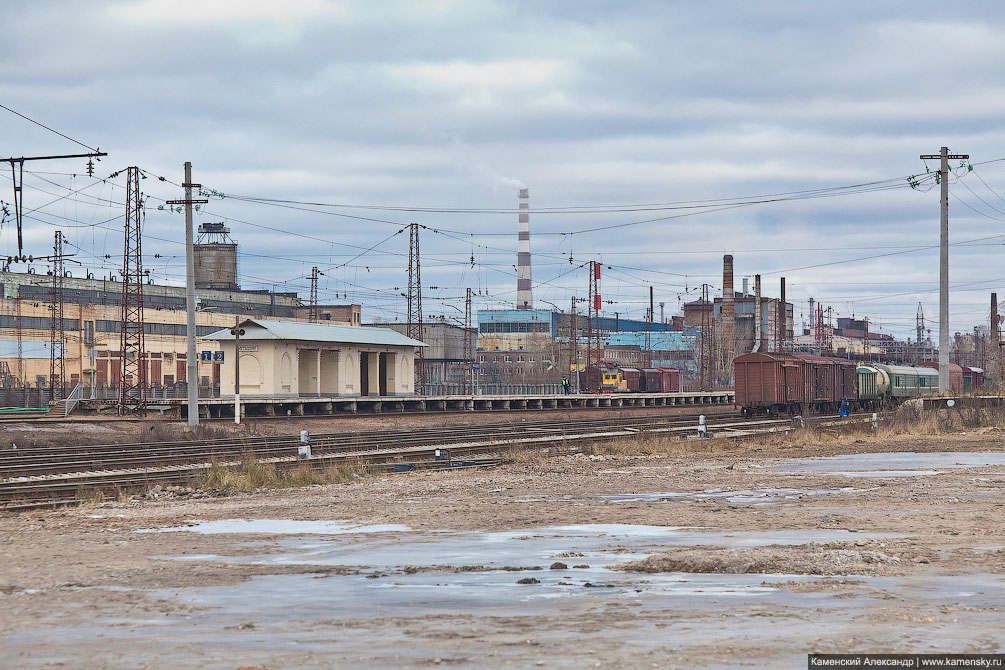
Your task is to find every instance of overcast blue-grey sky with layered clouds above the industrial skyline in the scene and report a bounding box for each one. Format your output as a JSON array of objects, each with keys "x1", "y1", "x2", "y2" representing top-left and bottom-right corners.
[{"x1": 0, "y1": 0, "x2": 1005, "y2": 338}]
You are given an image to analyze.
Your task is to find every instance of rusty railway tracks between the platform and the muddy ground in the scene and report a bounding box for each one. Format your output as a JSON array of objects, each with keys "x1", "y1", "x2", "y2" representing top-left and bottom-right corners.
[{"x1": 0, "y1": 413, "x2": 865, "y2": 509}]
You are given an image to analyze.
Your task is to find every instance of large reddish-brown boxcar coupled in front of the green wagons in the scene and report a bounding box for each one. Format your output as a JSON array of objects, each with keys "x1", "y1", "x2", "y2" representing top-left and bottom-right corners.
[{"x1": 734, "y1": 354, "x2": 857, "y2": 413}]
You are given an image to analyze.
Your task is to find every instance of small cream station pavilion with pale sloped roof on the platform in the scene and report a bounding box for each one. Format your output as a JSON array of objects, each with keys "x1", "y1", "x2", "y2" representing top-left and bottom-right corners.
[{"x1": 204, "y1": 318, "x2": 425, "y2": 398}]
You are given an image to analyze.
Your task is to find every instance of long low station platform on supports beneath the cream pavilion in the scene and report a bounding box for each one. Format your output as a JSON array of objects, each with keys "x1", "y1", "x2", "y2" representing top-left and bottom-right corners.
[{"x1": 88, "y1": 391, "x2": 734, "y2": 418}]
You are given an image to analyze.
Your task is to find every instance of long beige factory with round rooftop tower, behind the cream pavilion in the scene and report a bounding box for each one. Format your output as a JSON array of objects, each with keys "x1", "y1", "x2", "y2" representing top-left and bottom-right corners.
[{"x1": 0, "y1": 224, "x2": 362, "y2": 393}]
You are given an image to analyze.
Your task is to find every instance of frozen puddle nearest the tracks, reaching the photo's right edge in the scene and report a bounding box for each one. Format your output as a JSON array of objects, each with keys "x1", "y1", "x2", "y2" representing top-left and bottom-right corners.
[{"x1": 768, "y1": 451, "x2": 1005, "y2": 477}]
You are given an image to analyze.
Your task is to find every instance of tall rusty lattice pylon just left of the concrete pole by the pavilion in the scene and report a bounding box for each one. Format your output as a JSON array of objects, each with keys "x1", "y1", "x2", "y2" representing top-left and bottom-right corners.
[{"x1": 119, "y1": 168, "x2": 146, "y2": 414}]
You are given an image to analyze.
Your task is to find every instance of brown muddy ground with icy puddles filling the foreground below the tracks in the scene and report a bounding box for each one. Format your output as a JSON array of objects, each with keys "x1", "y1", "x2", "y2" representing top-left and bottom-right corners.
[{"x1": 0, "y1": 421, "x2": 1005, "y2": 670}]
